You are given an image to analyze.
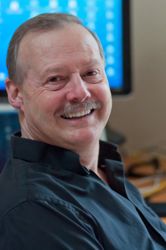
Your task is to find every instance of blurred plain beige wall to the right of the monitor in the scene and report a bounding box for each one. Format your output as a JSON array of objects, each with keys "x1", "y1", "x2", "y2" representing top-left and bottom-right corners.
[{"x1": 109, "y1": 0, "x2": 166, "y2": 151}]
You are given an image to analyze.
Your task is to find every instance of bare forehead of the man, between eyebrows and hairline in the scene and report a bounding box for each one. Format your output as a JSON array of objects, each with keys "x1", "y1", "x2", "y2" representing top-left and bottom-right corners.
[{"x1": 18, "y1": 24, "x2": 100, "y2": 65}]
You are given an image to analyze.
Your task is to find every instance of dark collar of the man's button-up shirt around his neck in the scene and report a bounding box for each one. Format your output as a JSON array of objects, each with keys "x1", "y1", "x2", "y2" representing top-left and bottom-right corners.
[{"x1": 11, "y1": 132, "x2": 121, "y2": 174}]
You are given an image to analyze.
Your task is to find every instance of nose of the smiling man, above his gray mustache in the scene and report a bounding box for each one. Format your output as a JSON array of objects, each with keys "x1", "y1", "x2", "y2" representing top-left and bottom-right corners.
[{"x1": 66, "y1": 74, "x2": 91, "y2": 102}]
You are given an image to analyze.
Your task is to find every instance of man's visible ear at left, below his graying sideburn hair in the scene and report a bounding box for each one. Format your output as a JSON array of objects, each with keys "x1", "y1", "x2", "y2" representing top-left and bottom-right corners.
[{"x1": 6, "y1": 78, "x2": 23, "y2": 109}]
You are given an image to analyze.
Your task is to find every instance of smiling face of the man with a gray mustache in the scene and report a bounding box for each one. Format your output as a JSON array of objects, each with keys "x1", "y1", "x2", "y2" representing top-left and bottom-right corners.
[{"x1": 15, "y1": 25, "x2": 111, "y2": 150}]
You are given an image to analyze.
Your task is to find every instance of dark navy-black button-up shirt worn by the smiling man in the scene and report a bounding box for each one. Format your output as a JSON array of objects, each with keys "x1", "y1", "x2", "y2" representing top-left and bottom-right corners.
[{"x1": 0, "y1": 136, "x2": 166, "y2": 250}]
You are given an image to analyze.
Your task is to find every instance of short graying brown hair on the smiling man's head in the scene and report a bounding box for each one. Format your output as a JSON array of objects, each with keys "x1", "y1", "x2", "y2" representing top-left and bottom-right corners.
[{"x1": 6, "y1": 13, "x2": 104, "y2": 83}]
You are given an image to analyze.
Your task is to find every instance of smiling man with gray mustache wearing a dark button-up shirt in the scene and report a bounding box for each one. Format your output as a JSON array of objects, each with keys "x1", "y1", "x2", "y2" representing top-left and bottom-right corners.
[{"x1": 0, "y1": 14, "x2": 166, "y2": 250}]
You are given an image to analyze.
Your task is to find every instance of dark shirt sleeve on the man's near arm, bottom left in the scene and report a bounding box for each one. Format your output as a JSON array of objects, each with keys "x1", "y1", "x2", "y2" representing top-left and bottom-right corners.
[{"x1": 0, "y1": 201, "x2": 103, "y2": 250}]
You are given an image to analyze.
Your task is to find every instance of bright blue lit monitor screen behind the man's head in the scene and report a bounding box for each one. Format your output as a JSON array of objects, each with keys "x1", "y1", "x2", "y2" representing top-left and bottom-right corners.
[{"x1": 0, "y1": 0, "x2": 123, "y2": 90}]
